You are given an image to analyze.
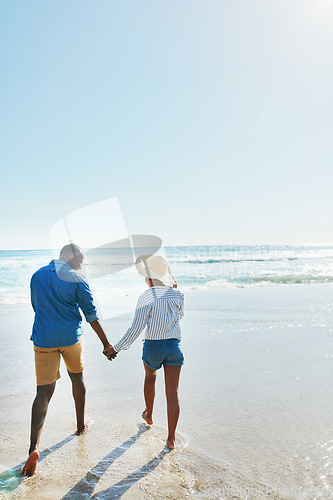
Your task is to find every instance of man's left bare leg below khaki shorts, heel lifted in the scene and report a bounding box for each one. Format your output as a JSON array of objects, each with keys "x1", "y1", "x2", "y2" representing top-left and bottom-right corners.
[{"x1": 23, "y1": 382, "x2": 56, "y2": 476}]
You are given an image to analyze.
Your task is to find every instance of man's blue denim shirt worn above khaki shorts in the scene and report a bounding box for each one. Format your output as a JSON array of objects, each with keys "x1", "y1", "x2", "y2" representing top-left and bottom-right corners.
[{"x1": 30, "y1": 260, "x2": 98, "y2": 347}]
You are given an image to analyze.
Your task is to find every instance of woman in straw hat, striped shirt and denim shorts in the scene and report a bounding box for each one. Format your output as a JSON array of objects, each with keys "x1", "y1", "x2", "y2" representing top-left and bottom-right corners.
[{"x1": 104, "y1": 255, "x2": 184, "y2": 449}]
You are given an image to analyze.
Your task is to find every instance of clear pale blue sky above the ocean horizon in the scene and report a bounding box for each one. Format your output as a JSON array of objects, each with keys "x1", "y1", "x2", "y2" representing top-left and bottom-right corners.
[{"x1": 0, "y1": 0, "x2": 333, "y2": 248}]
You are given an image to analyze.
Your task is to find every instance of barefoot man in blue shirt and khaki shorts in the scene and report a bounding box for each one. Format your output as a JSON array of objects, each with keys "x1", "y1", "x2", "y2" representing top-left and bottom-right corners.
[{"x1": 23, "y1": 243, "x2": 114, "y2": 476}]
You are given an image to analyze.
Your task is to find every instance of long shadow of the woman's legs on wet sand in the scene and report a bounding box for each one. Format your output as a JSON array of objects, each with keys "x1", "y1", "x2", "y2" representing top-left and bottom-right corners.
[{"x1": 61, "y1": 424, "x2": 169, "y2": 500}]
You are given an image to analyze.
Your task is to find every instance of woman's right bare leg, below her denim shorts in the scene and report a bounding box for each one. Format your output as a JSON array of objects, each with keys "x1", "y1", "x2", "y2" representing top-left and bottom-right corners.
[{"x1": 164, "y1": 365, "x2": 182, "y2": 450}]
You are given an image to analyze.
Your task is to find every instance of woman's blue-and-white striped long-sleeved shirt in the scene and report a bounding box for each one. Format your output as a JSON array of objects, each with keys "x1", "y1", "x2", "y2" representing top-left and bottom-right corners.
[{"x1": 113, "y1": 286, "x2": 184, "y2": 352}]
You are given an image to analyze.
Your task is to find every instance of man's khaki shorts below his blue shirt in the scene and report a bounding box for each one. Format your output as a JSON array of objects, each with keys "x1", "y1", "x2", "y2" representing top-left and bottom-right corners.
[{"x1": 34, "y1": 335, "x2": 83, "y2": 385}]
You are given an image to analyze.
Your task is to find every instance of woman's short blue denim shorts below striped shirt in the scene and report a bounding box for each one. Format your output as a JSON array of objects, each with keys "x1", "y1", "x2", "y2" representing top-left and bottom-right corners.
[{"x1": 142, "y1": 339, "x2": 184, "y2": 370}]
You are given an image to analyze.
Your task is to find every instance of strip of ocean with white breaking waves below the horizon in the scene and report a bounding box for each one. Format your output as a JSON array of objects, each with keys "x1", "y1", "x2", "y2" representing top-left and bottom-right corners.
[{"x1": 0, "y1": 244, "x2": 333, "y2": 304}]
